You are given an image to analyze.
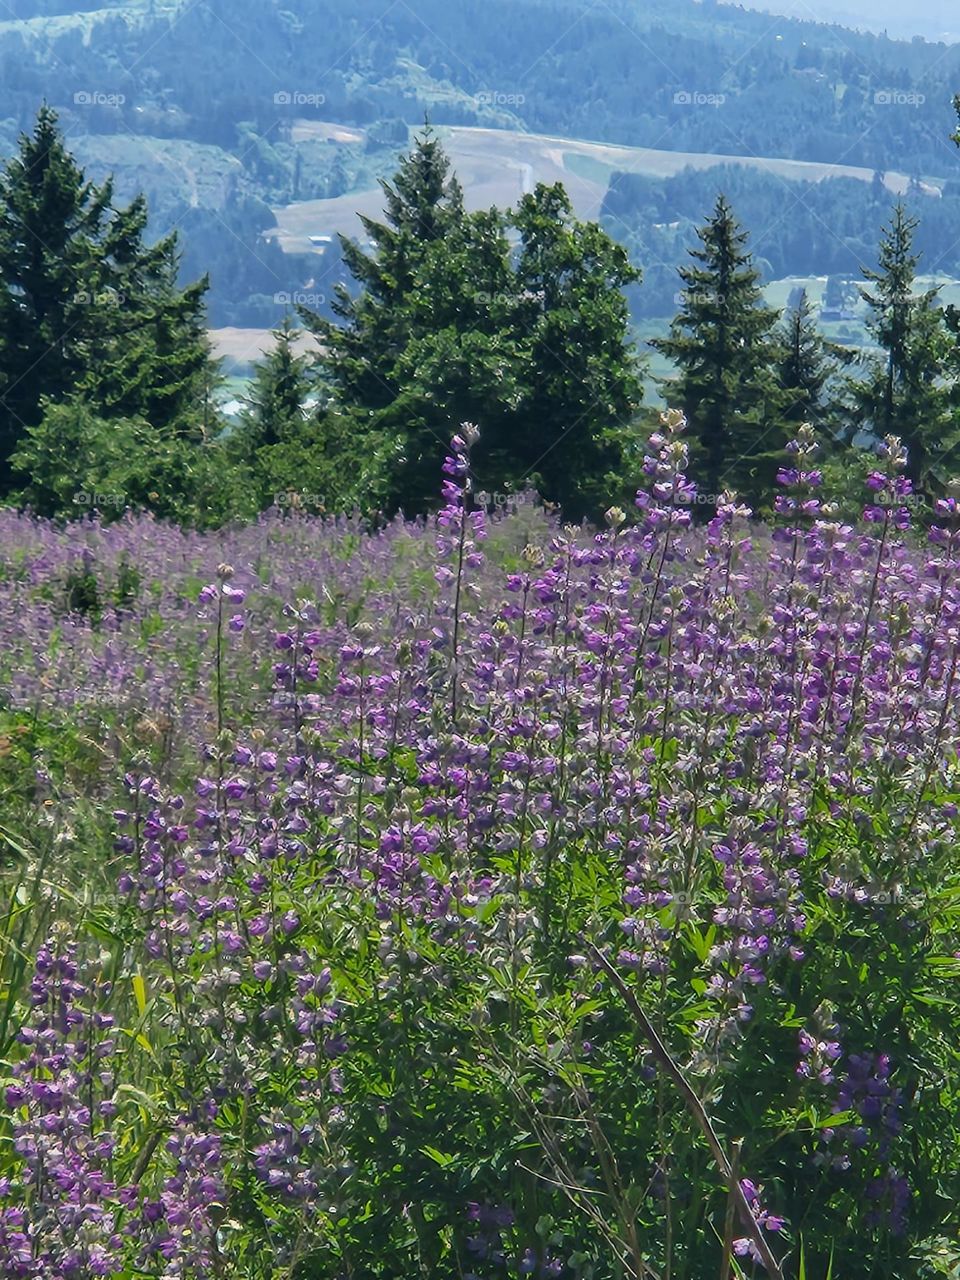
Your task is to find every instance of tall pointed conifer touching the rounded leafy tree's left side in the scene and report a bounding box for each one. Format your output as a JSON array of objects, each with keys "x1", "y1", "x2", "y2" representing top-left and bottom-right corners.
[{"x1": 301, "y1": 125, "x2": 496, "y2": 515}]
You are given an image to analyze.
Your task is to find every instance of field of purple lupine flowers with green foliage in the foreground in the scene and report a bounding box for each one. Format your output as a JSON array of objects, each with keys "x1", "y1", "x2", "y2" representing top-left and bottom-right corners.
[{"x1": 0, "y1": 413, "x2": 960, "y2": 1280}]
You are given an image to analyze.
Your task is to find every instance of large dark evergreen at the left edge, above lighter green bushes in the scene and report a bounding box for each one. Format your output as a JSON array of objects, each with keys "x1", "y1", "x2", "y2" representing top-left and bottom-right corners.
[{"x1": 0, "y1": 108, "x2": 216, "y2": 493}]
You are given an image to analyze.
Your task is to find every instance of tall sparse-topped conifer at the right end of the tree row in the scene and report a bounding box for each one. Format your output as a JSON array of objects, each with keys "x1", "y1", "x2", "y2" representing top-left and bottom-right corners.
[{"x1": 849, "y1": 204, "x2": 950, "y2": 488}]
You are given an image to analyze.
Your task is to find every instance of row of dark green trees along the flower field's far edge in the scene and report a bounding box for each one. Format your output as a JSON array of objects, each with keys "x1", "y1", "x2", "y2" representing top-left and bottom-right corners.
[{"x1": 0, "y1": 108, "x2": 960, "y2": 525}]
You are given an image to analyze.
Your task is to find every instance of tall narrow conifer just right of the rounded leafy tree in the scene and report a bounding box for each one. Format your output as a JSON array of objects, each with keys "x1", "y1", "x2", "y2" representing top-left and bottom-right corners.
[{"x1": 652, "y1": 196, "x2": 788, "y2": 506}]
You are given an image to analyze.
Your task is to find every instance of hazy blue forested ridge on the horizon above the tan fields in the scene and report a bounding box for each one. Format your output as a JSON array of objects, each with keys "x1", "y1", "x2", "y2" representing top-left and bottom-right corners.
[{"x1": 0, "y1": 0, "x2": 960, "y2": 173}]
